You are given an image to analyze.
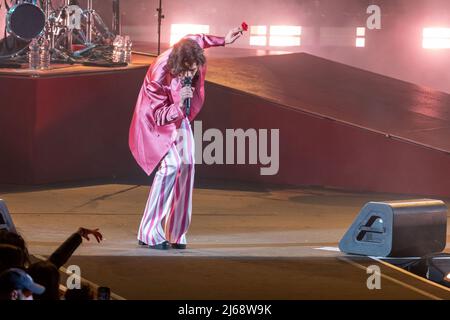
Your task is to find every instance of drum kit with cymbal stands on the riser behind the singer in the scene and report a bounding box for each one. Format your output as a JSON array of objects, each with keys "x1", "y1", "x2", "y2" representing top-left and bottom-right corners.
[{"x1": 0, "y1": 0, "x2": 115, "y2": 63}]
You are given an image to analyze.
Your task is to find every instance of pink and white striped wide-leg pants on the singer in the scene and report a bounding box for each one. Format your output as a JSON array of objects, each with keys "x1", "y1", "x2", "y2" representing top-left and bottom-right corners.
[{"x1": 138, "y1": 118, "x2": 195, "y2": 245}]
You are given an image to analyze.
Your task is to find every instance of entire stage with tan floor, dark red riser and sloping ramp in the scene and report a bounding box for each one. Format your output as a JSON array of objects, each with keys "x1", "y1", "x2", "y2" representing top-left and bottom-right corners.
[{"x1": 0, "y1": 48, "x2": 450, "y2": 300}]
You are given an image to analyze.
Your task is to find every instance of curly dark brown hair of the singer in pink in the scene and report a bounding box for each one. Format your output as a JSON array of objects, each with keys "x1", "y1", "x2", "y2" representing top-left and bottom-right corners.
[{"x1": 167, "y1": 38, "x2": 206, "y2": 76}]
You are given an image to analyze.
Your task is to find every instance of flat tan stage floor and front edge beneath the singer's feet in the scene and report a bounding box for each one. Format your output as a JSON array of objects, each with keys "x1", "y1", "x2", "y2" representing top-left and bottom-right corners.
[{"x1": 0, "y1": 181, "x2": 450, "y2": 299}]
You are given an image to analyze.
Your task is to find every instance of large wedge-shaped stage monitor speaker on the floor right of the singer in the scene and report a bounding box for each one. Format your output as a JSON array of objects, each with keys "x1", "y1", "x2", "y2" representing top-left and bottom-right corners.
[{"x1": 339, "y1": 199, "x2": 447, "y2": 257}]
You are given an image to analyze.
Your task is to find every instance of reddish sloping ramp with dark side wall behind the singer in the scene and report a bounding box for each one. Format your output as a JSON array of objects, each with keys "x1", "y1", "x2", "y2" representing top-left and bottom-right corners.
[{"x1": 199, "y1": 53, "x2": 450, "y2": 196}]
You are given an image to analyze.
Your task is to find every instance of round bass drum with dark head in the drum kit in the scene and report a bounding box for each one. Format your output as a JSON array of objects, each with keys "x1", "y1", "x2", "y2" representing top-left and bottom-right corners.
[{"x1": 6, "y1": 2, "x2": 45, "y2": 41}]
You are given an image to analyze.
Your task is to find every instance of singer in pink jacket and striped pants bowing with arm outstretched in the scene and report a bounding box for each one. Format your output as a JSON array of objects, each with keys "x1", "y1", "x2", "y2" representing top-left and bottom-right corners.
[{"x1": 129, "y1": 26, "x2": 243, "y2": 250}]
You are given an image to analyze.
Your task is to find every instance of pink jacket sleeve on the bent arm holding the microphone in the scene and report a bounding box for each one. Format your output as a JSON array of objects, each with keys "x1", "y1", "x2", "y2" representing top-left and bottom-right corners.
[{"x1": 145, "y1": 80, "x2": 184, "y2": 126}]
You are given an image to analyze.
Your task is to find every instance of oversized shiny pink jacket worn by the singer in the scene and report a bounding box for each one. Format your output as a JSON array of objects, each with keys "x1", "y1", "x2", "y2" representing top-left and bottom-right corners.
[{"x1": 128, "y1": 34, "x2": 225, "y2": 175}]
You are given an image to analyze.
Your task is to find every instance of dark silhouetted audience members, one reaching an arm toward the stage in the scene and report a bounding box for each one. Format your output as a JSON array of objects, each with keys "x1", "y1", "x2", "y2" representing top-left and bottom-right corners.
[{"x1": 0, "y1": 227, "x2": 109, "y2": 300}]
